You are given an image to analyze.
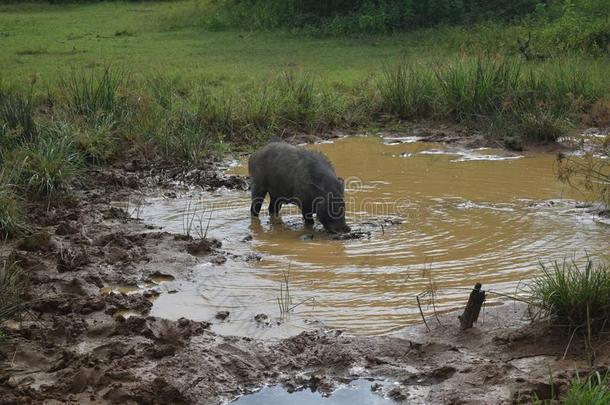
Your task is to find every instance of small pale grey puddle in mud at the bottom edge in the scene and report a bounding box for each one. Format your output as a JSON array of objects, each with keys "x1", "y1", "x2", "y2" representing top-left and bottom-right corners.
[{"x1": 231, "y1": 379, "x2": 395, "y2": 405}]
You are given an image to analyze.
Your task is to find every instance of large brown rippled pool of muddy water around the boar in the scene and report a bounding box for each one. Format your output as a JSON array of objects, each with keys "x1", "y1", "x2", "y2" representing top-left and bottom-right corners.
[{"x1": 135, "y1": 137, "x2": 610, "y2": 336}]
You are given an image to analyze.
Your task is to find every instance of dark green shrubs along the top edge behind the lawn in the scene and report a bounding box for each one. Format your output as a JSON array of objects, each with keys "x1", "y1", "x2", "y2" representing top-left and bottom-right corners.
[{"x1": 198, "y1": 0, "x2": 610, "y2": 49}]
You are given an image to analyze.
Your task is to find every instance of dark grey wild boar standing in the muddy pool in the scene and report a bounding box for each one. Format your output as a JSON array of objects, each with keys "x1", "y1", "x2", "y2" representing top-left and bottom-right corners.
[{"x1": 248, "y1": 142, "x2": 350, "y2": 233}]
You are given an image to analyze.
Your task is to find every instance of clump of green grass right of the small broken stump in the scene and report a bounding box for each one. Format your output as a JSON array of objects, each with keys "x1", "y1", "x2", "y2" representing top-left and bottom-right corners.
[{"x1": 531, "y1": 259, "x2": 610, "y2": 332}]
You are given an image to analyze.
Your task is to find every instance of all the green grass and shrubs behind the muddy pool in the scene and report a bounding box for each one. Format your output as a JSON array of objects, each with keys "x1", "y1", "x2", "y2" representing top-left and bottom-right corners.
[{"x1": 0, "y1": 0, "x2": 610, "y2": 237}]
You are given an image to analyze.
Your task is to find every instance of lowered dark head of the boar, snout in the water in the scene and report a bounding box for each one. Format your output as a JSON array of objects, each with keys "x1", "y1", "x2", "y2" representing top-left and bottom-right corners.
[{"x1": 315, "y1": 177, "x2": 351, "y2": 233}]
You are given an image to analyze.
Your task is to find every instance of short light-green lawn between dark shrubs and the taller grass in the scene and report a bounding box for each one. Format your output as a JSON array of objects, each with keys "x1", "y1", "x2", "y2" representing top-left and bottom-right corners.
[{"x1": 0, "y1": 2, "x2": 455, "y2": 86}]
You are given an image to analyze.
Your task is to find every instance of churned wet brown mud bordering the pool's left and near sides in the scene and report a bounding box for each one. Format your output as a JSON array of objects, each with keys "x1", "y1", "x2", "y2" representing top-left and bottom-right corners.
[{"x1": 0, "y1": 131, "x2": 610, "y2": 404}]
